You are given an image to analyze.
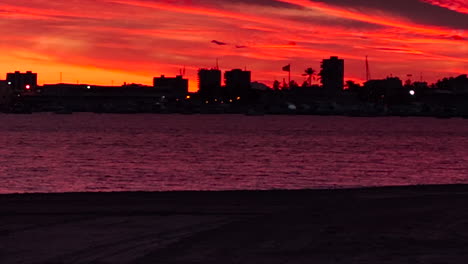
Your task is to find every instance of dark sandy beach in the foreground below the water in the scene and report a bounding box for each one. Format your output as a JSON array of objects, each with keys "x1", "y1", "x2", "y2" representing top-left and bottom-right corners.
[{"x1": 0, "y1": 186, "x2": 468, "y2": 264}]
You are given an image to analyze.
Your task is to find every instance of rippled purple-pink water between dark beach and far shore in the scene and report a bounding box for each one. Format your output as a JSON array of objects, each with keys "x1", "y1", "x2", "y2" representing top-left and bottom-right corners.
[{"x1": 0, "y1": 114, "x2": 468, "y2": 193}]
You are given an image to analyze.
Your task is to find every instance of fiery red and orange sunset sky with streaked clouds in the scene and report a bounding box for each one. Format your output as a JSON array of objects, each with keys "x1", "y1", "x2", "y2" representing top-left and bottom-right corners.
[{"x1": 0, "y1": 0, "x2": 468, "y2": 91}]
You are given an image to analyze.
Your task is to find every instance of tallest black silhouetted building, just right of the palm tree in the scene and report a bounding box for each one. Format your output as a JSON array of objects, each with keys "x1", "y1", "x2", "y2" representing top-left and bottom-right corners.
[{"x1": 320, "y1": 57, "x2": 344, "y2": 95}]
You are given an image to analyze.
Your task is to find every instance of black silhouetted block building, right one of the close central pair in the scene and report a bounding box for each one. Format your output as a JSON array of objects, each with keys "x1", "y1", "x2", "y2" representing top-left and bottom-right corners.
[{"x1": 224, "y1": 69, "x2": 252, "y2": 96}]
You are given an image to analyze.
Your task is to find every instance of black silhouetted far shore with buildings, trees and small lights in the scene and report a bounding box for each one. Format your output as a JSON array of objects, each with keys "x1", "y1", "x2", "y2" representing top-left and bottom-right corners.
[{"x1": 0, "y1": 57, "x2": 468, "y2": 118}]
